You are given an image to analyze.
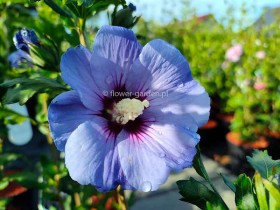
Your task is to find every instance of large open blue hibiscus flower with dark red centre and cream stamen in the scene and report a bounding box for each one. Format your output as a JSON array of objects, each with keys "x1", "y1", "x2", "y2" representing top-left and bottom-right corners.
[{"x1": 48, "y1": 26, "x2": 210, "y2": 191}]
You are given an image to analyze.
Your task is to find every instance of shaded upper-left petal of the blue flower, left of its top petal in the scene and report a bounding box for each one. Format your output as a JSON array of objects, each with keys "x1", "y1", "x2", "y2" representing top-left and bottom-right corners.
[{"x1": 60, "y1": 45, "x2": 102, "y2": 110}]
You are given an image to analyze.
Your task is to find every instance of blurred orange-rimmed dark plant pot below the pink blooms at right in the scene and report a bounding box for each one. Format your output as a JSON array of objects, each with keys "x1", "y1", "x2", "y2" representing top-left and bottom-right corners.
[{"x1": 226, "y1": 132, "x2": 269, "y2": 174}]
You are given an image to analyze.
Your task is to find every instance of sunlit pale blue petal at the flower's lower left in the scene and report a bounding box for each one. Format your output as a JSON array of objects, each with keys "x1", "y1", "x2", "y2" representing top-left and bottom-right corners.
[{"x1": 65, "y1": 118, "x2": 124, "y2": 192}]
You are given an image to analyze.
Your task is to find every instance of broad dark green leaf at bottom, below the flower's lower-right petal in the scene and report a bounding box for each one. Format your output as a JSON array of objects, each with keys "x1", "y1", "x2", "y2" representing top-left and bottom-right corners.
[{"x1": 177, "y1": 177, "x2": 227, "y2": 209}]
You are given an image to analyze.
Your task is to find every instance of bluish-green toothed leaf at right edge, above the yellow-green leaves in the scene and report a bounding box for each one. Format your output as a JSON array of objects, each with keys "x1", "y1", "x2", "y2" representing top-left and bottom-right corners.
[{"x1": 247, "y1": 150, "x2": 280, "y2": 179}]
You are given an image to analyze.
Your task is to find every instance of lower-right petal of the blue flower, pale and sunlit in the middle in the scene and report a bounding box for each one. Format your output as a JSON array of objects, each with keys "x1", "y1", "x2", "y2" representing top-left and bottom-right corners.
[{"x1": 141, "y1": 112, "x2": 200, "y2": 171}]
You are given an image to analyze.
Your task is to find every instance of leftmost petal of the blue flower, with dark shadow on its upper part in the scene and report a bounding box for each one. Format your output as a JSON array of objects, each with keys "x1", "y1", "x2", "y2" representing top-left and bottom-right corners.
[{"x1": 48, "y1": 91, "x2": 95, "y2": 151}]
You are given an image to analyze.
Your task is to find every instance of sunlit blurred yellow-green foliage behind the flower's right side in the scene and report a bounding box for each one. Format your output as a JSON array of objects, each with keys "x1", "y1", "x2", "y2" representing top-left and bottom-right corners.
[{"x1": 137, "y1": 8, "x2": 280, "y2": 141}]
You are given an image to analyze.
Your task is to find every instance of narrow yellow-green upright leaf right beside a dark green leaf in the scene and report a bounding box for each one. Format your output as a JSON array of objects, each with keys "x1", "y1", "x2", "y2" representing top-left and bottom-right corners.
[{"x1": 254, "y1": 173, "x2": 268, "y2": 210}]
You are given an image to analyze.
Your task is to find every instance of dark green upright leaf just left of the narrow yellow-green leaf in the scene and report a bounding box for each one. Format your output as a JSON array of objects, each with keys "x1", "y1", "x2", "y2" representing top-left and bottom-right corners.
[{"x1": 234, "y1": 174, "x2": 257, "y2": 210}]
